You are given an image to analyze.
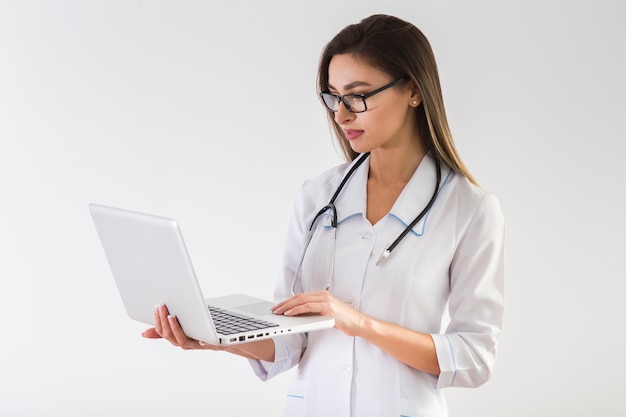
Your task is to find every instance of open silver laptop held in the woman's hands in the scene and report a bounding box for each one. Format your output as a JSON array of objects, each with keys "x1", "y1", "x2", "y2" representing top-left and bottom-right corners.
[{"x1": 89, "y1": 204, "x2": 335, "y2": 345}]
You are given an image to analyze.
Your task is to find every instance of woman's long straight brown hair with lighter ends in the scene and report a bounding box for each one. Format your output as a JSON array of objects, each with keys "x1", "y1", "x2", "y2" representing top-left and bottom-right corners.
[{"x1": 317, "y1": 14, "x2": 477, "y2": 184}]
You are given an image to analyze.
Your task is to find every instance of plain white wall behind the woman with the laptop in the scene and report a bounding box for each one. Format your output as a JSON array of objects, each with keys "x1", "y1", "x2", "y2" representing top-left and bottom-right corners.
[{"x1": 0, "y1": 0, "x2": 626, "y2": 417}]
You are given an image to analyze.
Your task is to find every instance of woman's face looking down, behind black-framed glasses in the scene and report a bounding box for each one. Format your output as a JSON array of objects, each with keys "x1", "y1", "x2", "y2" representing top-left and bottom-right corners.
[{"x1": 328, "y1": 54, "x2": 420, "y2": 153}]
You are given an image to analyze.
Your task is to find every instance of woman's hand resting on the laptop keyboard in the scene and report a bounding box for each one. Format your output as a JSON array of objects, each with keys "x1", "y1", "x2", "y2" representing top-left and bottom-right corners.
[{"x1": 272, "y1": 291, "x2": 366, "y2": 336}]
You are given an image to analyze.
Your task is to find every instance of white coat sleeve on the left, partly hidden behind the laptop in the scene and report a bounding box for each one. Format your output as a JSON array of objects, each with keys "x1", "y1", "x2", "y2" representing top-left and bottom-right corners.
[{"x1": 250, "y1": 182, "x2": 308, "y2": 381}]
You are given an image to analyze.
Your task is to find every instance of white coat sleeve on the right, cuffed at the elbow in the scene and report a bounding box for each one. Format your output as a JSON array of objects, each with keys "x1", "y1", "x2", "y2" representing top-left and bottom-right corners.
[{"x1": 432, "y1": 195, "x2": 504, "y2": 388}]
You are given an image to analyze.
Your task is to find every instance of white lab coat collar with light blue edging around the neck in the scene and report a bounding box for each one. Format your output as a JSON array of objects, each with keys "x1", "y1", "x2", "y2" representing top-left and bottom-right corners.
[{"x1": 335, "y1": 154, "x2": 451, "y2": 236}]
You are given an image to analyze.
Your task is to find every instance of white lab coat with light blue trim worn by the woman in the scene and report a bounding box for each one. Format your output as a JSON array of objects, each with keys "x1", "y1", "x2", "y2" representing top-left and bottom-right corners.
[{"x1": 251, "y1": 156, "x2": 504, "y2": 417}]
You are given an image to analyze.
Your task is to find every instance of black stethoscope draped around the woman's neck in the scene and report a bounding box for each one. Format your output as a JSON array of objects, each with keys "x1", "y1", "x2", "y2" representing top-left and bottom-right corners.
[{"x1": 291, "y1": 152, "x2": 441, "y2": 294}]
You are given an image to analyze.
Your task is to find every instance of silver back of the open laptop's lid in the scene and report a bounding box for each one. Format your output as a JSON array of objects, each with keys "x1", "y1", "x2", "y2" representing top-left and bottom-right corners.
[{"x1": 89, "y1": 204, "x2": 218, "y2": 344}]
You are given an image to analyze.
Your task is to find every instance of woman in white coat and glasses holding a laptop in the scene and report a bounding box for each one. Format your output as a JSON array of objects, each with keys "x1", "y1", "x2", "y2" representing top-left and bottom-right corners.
[{"x1": 144, "y1": 15, "x2": 504, "y2": 417}]
